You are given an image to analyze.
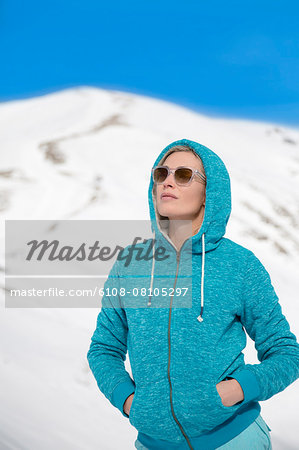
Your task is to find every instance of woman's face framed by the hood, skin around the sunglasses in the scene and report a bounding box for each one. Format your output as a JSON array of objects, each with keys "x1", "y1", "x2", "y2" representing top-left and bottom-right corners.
[{"x1": 156, "y1": 152, "x2": 206, "y2": 220}]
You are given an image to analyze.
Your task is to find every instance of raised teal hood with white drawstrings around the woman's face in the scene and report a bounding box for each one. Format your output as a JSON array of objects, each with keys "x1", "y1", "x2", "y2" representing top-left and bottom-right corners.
[{"x1": 148, "y1": 139, "x2": 231, "y2": 321}]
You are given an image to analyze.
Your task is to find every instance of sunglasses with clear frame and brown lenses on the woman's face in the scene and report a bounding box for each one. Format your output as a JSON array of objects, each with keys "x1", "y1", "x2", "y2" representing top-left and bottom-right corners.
[{"x1": 152, "y1": 166, "x2": 206, "y2": 186}]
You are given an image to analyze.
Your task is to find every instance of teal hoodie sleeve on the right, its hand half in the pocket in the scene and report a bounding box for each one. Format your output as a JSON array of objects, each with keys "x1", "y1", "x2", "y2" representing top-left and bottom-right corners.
[{"x1": 227, "y1": 252, "x2": 299, "y2": 404}]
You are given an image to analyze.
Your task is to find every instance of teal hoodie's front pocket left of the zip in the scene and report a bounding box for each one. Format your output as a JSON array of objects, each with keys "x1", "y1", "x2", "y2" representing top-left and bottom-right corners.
[{"x1": 129, "y1": 380, "x2": 180, "y2": 441}]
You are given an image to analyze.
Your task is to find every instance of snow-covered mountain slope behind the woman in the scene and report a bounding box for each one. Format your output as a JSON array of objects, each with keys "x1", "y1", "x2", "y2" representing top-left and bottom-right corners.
[{"x1": 0, "y1": 87, "x2": 299, "y2": 450}]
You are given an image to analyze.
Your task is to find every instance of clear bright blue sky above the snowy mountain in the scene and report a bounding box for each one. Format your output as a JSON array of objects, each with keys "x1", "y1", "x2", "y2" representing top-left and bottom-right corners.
[{"x1": 0, "y1": 0, "x2": 299, "y2": 126}]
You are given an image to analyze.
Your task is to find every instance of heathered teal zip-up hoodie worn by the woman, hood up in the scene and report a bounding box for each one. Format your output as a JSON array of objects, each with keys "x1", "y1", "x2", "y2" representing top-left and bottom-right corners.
[{"x1": 87, "y1": 139, "x2": 299, "y2": 450}]
